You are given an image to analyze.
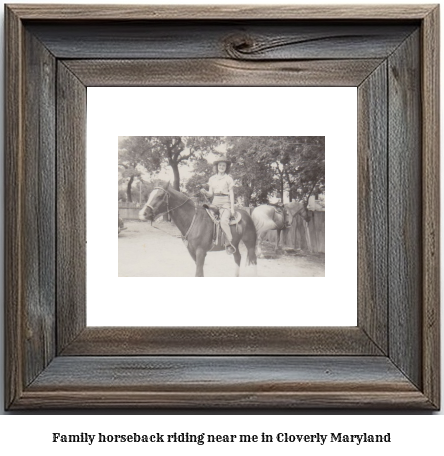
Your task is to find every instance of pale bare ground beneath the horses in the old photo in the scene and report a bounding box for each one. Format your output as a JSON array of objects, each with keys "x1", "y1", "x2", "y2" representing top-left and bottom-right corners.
[{"x1": 119, "y1": 221, "x2": 325, "y2": 277}]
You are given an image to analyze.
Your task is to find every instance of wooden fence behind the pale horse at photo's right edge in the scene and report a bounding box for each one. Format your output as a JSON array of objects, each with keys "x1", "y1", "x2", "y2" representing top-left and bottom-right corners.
[{"x1": 265, "y1": 211, "x2": 325, "y2": 253}]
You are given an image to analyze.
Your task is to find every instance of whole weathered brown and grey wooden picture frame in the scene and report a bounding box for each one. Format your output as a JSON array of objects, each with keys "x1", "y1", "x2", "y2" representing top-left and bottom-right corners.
[{"x1": 5, "y1": 4, "x2": 440, "y2": 410}]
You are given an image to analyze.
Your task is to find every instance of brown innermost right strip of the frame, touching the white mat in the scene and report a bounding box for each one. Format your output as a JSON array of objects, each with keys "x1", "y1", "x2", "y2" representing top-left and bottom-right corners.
[{"x1": 358, "y1": 61, "x2": 389, "y2": 354}]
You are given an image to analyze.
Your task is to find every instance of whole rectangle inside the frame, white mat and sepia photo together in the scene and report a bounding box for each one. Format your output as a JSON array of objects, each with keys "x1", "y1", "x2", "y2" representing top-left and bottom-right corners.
[{"x1": 86, "y1": 87, "x2": 358, "y2": 326}]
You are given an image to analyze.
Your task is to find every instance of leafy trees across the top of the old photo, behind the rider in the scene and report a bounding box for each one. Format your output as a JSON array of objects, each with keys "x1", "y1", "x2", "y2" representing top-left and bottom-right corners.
[{"x1": 119, "y1": 136, "x2": 325, "y2": 206}]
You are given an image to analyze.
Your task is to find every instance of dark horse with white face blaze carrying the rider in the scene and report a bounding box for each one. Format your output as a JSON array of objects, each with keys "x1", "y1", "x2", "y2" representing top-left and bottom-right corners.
[{"x1": 139, "y1": 184, "x2": 257, "y2": 277}]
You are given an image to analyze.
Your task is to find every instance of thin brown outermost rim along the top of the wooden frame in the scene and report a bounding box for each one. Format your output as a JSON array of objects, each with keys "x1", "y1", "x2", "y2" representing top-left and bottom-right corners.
[{"x1": 8, "y1": 4, "x2": 436, "y2": 21}]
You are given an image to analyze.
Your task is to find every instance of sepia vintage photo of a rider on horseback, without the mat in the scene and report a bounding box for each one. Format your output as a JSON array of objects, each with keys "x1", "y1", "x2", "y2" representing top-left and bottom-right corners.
[{"x1": 118, "y1": 136, "x2": 325, "y2": 277}]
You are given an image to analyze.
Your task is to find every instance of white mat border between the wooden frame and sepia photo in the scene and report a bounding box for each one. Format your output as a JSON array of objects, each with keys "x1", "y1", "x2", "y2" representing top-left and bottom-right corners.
[{"x1": 87, "y1": 87, "x2": 357, "y2": 326}]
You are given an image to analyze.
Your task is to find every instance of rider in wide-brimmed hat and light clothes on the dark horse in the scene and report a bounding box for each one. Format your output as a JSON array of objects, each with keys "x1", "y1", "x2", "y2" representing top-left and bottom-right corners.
[{"x1": 200, "y1": 157, "x2": 236, "y2": 255}]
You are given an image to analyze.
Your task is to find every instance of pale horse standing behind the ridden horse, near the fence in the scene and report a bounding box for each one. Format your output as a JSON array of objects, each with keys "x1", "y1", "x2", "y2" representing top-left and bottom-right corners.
[{"x1": 251, "y1": 201, "x2": 310, "y2": 256}]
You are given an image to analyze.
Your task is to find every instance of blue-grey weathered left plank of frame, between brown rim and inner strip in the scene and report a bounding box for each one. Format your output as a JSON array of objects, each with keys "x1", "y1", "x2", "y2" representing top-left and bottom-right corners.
[{"x1": 22, "y1": 26, "x2": 56, "y2": 385}]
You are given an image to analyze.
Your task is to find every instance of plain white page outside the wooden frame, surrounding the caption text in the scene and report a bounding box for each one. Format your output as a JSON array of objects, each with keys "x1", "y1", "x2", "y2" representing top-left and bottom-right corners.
[{"x1": 0, "y1": 0, "x2": 444, "y2": 450}]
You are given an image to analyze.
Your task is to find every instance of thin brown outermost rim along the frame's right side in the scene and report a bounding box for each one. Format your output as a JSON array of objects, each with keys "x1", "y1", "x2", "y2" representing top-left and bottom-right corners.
[{"x1": 421, "y1": 6, "x2": 441, "y2": 407}]
